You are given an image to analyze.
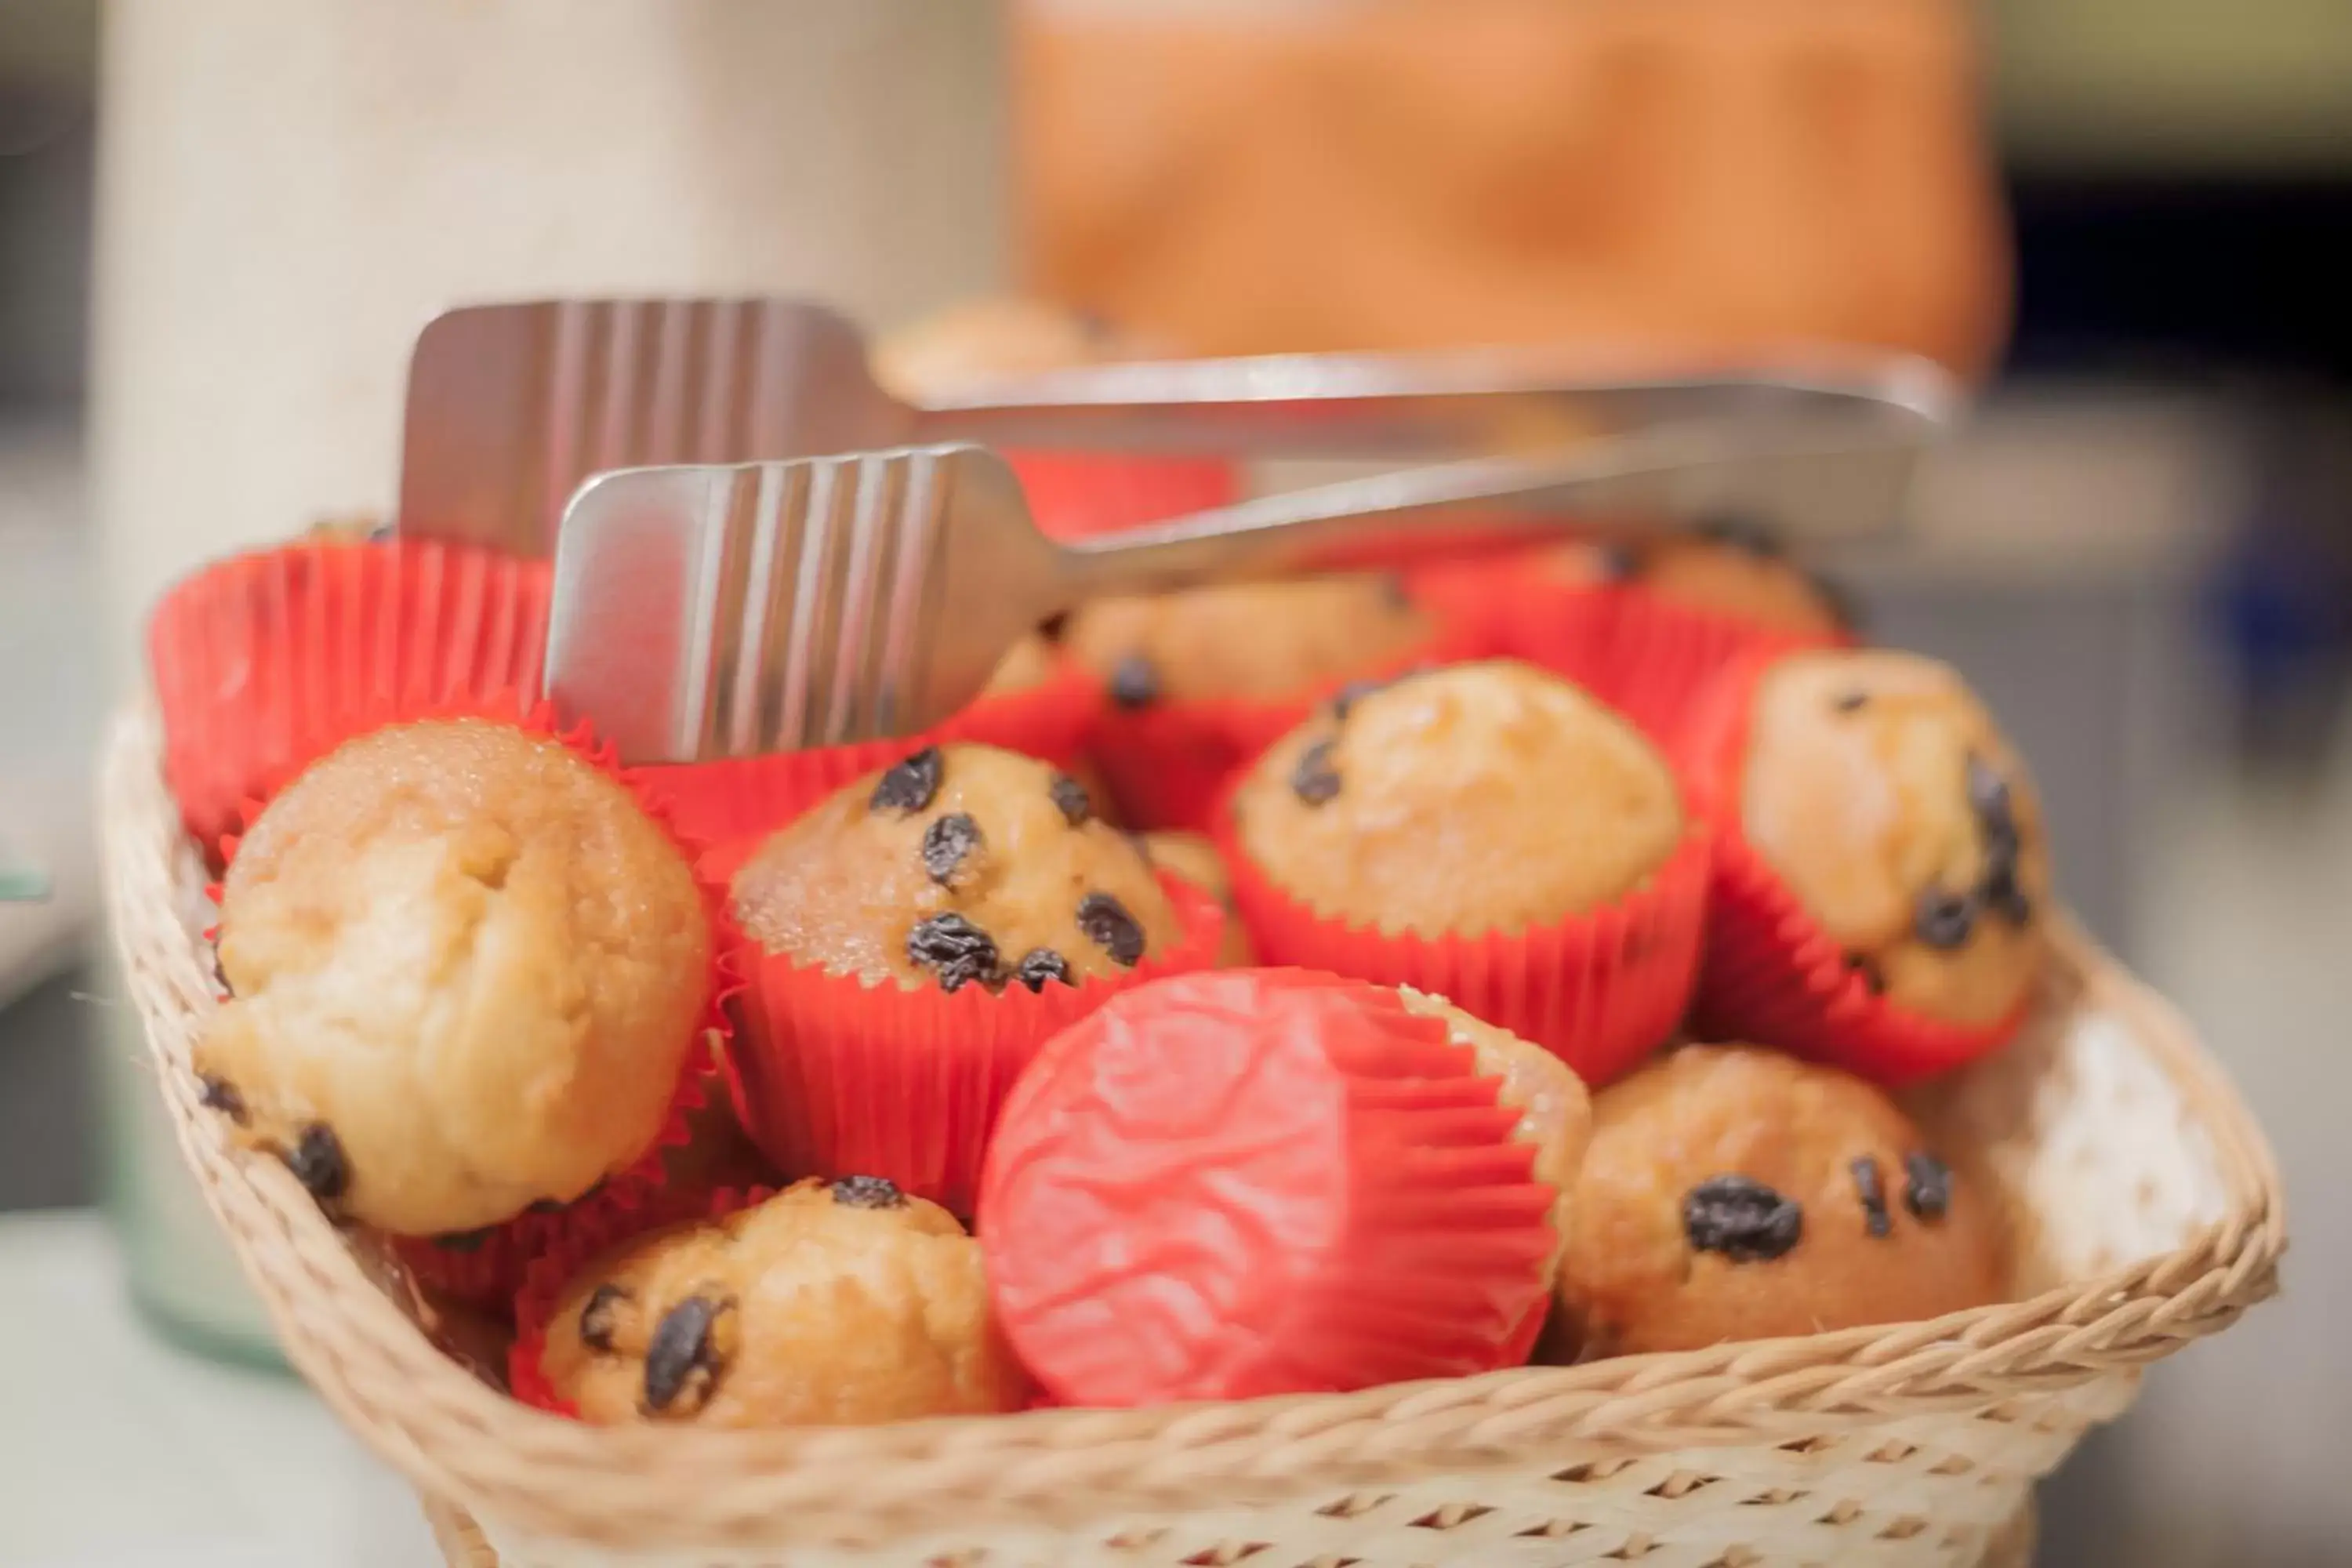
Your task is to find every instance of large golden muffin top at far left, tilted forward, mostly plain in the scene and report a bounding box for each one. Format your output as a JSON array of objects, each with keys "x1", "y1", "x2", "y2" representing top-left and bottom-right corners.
[{"x1": 195, "y1": 720, "x2": 713, "y2": 1236}]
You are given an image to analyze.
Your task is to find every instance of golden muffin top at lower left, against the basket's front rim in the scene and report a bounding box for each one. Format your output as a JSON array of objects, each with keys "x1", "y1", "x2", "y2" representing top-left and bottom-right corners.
[{"x1": 539, "y1": 1175, "x2": 1023, "y2": 1427}]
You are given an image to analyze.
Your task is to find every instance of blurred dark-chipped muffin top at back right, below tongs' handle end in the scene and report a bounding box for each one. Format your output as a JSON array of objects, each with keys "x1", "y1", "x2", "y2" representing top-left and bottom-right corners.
[{"x1": 1545, "y1": 520, "x2": 1851, "y2": 637}]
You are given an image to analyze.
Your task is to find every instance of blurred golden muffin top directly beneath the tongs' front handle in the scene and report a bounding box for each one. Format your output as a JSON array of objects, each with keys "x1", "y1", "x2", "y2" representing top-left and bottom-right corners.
[{"x1": 1063, "y1": 574, "x2": 1437, "y2": 708}]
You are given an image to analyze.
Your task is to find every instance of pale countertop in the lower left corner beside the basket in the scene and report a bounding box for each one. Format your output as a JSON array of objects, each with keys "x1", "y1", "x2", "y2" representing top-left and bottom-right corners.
[{"x1": 0, "y1": 1210, "x2": 442, "y2": 1568}]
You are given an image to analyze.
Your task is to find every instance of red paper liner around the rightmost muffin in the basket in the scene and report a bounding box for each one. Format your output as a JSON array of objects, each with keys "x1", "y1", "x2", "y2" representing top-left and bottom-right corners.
[{"x1": 1679, "y1": 649, "x2": 2030, "y2": 1086}]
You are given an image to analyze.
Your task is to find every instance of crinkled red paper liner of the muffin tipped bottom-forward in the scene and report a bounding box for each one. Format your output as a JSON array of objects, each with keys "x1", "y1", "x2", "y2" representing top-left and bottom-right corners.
[{"x1": 981, "y1": 971, "x2": 1555, "y2": 1406}]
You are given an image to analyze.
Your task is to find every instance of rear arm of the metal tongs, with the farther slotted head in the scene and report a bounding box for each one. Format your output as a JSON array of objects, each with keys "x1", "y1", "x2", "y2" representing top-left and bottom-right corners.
[{"x1": 400, "y1": 299, "x2": 1957, "y2": 555}]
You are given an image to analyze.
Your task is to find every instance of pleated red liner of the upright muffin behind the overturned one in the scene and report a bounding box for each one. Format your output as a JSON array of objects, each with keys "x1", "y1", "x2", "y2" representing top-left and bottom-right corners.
[{"x1": 1216, "y1": 806, "x2": 1710, "y2": 1088}]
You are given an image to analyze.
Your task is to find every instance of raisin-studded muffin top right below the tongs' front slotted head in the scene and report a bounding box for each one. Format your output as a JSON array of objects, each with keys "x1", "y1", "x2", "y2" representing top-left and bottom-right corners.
[{"x1": 734, "y1": 746, "x2": 1181, "y2": 992}]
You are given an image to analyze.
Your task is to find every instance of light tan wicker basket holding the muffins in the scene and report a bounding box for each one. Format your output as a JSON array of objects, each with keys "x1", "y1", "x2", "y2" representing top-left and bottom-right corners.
[{"x1": 103, "y1": 710, "x2": 2286, "y2": 1568}]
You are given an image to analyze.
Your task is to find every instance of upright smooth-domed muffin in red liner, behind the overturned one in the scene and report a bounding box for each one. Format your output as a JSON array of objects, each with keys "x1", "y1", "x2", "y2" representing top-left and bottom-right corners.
[{"x1": 1216, "y1": 661, "x2": 1708, "y2": 1083}]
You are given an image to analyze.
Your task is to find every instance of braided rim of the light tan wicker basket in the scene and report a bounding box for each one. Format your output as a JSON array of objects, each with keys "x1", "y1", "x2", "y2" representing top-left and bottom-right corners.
[{"x1": 99, "y1": 703, "x2": 2286, "y2": 1549}]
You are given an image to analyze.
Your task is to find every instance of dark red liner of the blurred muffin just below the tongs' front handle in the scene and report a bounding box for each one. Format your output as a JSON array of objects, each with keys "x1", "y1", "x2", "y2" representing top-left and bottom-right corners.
[{"x1": 1087, "y1": 614, "x2": 1494, "y2": 832}]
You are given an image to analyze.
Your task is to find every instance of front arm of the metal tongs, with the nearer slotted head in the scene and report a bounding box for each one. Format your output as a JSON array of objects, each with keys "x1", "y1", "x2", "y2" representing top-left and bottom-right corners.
[{"x1": 546, "y1": 404, "x2": 1922, "y2": 762}]
